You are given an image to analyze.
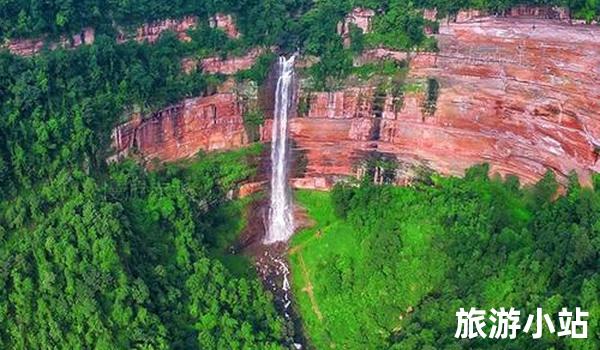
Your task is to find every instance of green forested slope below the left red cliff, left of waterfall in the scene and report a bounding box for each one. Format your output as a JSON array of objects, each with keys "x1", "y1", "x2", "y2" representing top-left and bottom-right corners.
[{"x1": 0, "y1": 148, "x2": 285, "y2": 349}]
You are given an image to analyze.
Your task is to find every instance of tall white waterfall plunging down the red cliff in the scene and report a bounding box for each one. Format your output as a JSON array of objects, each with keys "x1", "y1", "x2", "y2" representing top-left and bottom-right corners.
[{"x1": 265, "y1": 56, "x2": 294, "y2": 244}]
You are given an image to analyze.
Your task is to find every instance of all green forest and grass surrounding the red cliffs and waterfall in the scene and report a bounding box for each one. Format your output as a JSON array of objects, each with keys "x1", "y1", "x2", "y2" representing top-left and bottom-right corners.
[{"x1": 0, "y1": 0, "x2": 600, "y2": 349}]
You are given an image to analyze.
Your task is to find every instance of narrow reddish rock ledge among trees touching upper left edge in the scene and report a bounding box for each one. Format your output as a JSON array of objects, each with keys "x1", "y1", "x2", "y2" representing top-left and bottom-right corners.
[{"x1": 2, "y1": 28, "x2": 95, "y2": 56}]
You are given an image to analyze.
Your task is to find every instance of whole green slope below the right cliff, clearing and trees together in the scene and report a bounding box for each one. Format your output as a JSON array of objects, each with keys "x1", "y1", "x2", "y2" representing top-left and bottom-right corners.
[{"x1": 290, "y1": 166, "x2": 600, "y2": 350}]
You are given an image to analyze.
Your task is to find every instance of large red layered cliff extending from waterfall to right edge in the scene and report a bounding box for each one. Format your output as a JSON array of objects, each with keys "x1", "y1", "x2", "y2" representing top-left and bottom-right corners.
[{"x1": 290, "y1": 12, "x2": 600, "y2": 189}]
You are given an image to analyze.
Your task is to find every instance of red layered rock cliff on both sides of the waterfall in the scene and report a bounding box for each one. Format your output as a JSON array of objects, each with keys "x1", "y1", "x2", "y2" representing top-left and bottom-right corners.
[{"x1": 114, "y1": 10, "x2": 600, "y2": 192}]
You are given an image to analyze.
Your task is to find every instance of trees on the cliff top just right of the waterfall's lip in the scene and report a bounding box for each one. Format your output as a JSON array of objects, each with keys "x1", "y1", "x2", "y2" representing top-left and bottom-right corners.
[{"x1": 300, "y1": 0, "x2": 435, "y2": 90}]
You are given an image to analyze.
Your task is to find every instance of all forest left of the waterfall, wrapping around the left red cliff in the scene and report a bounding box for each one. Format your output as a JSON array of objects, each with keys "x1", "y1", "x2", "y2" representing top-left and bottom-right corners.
[{"x1": 0, "y1": 2, "x2": 287, "y2": 349}]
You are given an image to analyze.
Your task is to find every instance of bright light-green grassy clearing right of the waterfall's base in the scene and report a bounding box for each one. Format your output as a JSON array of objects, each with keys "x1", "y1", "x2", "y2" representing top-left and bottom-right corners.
[{"x1": 290, "y1": 191, "x2": 443, "y2": 349}]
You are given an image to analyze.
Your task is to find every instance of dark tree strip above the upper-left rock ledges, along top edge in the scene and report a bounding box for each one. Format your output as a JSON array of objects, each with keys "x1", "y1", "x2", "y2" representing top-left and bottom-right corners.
[{"x1": 0, "y1": 0, "x2": 310, "y2": 44}]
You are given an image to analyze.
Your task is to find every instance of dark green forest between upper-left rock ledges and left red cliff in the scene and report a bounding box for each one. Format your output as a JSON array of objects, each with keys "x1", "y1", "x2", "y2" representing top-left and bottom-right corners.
[{"x1": 0, "y1": 35, "x2": 214, "y2": 194}]
